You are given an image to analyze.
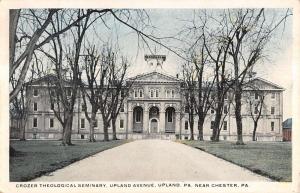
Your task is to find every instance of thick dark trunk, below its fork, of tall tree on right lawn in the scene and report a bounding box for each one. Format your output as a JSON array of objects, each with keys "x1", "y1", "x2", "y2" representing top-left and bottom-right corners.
[{"x1": 235, "y1": 89, "x2": 244, "y2": 145}]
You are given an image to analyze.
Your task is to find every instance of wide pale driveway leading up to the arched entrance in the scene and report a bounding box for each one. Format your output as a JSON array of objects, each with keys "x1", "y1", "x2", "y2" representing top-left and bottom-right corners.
[{"x1": 34, "y1": 140, "x2": 271, "y2": 181}]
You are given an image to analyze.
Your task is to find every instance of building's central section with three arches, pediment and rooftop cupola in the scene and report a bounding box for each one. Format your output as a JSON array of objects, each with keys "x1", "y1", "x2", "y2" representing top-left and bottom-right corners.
[{"x1": 126, "y1": 55, "x2": 182, "y2": 137}]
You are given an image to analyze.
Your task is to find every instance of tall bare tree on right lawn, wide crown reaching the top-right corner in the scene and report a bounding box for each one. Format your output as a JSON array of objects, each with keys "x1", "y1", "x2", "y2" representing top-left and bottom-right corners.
[{"x1": 226, "y1": 9, "x2": 291, "y2": 144}]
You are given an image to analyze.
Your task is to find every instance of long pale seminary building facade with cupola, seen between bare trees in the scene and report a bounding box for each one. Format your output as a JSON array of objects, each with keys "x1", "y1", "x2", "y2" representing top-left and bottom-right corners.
[{"x1": 20, "y1": 55, "x2": 283, "y2": 141}]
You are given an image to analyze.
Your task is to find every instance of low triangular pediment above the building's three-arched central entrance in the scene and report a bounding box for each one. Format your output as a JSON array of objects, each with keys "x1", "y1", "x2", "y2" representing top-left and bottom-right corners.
[{"x1": 130, "y1": 72, "x2": 179, "y2": 82}]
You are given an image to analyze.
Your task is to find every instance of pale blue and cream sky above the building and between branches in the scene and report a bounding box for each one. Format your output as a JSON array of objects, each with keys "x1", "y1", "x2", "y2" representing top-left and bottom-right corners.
[{"x1": 72, "y1": 9, "x2": 293, "y2": 120}]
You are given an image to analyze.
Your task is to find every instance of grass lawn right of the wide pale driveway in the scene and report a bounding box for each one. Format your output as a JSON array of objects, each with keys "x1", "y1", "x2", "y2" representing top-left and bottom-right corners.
[{"x1": 180, "y1": 141, "x2": 292, "y2": 182}]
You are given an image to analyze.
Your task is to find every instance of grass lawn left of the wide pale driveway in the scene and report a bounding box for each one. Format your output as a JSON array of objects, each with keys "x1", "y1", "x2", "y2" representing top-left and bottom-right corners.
[{"x1": 9, "y1": 140, "x2": 127, "y2": 182}]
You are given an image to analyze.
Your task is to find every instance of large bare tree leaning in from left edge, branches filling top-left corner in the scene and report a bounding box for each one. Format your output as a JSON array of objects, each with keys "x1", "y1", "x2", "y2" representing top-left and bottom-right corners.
[{"x1": 9, "y1": 9, "x2": 109, "y2": 101}]
